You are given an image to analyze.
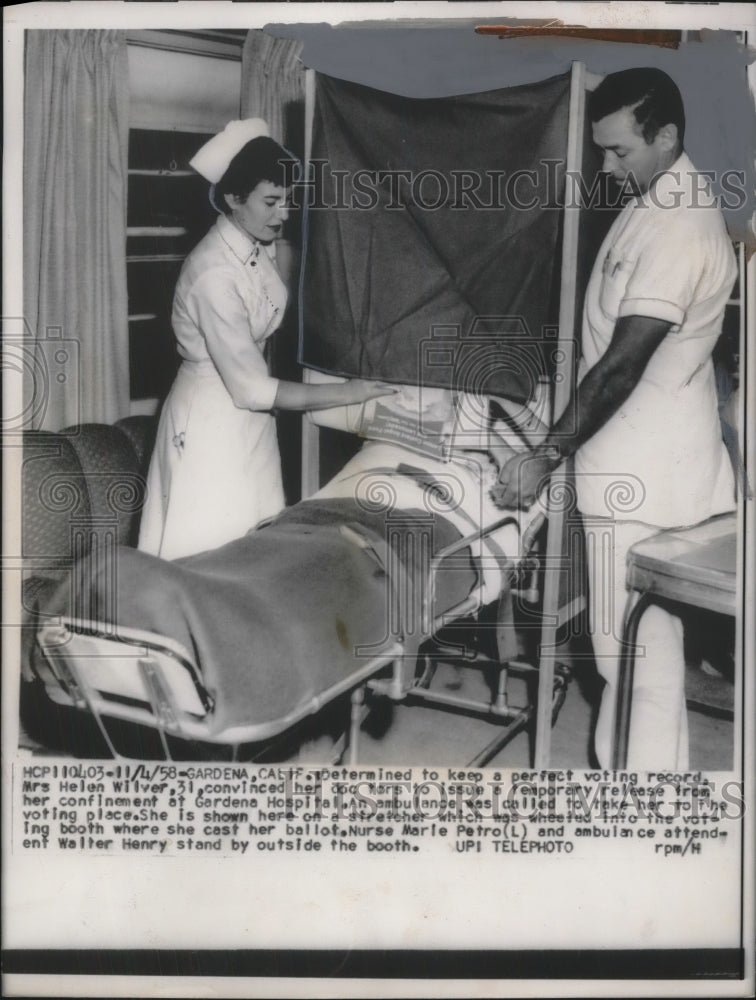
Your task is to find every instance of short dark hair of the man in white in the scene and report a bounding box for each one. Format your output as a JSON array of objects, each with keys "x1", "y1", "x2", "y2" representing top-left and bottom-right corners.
[{"x1": 588, "y1": 67, "x2": 685, "y2": 149}]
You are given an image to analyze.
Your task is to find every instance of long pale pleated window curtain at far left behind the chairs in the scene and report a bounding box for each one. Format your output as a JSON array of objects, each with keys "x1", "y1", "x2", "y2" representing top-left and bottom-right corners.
[{"x1": 24, "y1": 30, "x2": 129, "y2": 430}]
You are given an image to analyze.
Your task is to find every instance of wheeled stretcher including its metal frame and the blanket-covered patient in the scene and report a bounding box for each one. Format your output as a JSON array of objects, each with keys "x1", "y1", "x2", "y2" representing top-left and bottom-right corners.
[{"x1": 34, "y1": 443, "x2": 566, "y2": 763}]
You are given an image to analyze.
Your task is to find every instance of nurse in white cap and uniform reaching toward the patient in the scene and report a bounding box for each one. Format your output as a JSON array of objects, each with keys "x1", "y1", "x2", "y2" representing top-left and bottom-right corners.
[{"x1": 139, "y1": 118, "x2": 394, "y2": 559}]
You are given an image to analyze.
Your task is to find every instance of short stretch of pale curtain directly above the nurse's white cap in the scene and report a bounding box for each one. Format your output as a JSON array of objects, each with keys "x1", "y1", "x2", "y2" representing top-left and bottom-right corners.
[{"x1": 241, "y1": 29, "x2": 305, "y2": 146}]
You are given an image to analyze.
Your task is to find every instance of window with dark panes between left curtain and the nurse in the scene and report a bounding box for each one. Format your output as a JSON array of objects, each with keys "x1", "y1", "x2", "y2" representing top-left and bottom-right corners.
[{"x1": 126, "y1": 31, "x2": 246, "y2": 413}]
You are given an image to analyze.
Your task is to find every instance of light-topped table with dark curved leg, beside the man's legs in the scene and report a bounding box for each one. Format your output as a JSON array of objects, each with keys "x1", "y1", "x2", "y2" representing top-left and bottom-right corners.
[{"x1": 613, "y1": 512, "x2": 737, "y2": 768}]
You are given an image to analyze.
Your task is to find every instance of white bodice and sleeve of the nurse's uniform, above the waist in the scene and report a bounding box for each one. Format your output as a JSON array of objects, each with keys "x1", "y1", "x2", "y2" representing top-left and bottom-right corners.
[{"x1": 172, "y1": 215, "x2": 286, "y2": 410}]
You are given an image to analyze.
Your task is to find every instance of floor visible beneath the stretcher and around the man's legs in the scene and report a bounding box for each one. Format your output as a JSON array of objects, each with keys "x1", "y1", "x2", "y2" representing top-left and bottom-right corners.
[{"x1": 20, "y1": 624, "x2": 733, "y2": 770}]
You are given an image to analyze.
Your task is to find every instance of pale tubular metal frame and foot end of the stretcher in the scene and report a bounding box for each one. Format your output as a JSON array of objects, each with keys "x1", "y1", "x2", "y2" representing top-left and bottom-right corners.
[{"x1": 38, "y1": 515, "x2": 548, "y2": 764}]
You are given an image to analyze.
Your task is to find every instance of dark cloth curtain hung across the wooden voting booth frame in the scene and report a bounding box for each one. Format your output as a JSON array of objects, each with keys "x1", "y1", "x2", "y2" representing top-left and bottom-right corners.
[{"x1": 300, "y1": 75, "x2": 569, "y2": 401}]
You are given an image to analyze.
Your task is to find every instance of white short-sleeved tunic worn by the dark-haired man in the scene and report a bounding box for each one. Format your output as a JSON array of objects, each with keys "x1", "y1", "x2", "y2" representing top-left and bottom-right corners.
[{"x1": 575, "y1": 154, "x2": 736, "y2": 527}]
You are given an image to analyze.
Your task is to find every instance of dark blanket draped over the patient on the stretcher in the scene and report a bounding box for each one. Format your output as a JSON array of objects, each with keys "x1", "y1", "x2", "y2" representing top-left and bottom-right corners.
[{"x1": 35, "y1": 499, "x2": 476, "y2": 732}]
